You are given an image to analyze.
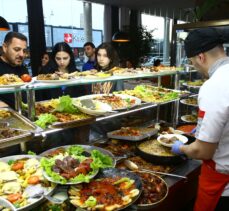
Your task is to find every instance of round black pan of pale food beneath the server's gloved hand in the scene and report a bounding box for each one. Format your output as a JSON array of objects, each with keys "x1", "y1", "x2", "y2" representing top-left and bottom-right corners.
[{"x1": 136, "y1": 139, "x2": 186, "y2": 165}]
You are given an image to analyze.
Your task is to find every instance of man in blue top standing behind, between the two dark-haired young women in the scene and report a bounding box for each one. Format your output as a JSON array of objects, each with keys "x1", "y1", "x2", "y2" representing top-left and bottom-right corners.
[{"x1": 82, "y1": 42, "x2": 95, "y2": 71}]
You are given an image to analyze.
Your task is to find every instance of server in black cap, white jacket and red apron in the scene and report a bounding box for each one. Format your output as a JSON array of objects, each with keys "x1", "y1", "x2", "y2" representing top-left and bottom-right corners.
[{"x1": 172, "y1": 28, "x2": 229, "y2": 211}]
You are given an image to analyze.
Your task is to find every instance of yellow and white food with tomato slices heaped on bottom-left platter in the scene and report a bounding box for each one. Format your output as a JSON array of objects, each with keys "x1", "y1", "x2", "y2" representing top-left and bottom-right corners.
[{"x1": 0, "y1": 155, "x2": 55, "y2": 210}]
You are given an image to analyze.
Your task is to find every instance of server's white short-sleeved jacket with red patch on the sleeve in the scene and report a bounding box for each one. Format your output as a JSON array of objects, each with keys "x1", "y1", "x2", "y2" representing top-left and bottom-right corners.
[{"x1": 195, "y1": 58, "x2": 229, "y2": 196}]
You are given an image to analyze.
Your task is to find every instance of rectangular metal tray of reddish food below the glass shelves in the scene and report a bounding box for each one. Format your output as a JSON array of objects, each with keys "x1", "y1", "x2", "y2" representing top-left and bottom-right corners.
[{"x1": 107, "y1": 127, "x2": 157, "y2": 141}]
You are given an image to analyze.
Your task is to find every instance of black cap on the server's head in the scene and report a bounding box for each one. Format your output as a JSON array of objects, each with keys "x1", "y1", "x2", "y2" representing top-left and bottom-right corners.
[{"x1": 184, "y1": 28, "x2": 227, "y2": 58}]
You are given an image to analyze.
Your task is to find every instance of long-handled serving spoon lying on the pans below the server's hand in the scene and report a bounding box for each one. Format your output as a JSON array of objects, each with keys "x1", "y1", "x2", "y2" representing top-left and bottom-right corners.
[{"x1": 124, "y1": 160, "x2": 188, "y2": 179}]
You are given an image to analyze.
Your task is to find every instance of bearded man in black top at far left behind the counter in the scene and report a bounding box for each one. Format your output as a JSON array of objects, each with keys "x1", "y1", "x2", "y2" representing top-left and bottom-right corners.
[{"x1": 0, "y1": 32, "x2": 28, "y2": 108}]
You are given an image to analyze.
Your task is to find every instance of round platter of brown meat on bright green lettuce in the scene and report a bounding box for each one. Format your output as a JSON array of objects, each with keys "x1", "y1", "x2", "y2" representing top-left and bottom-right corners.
[{"x1": 41, "y1": 145, "x2": 113, "y2": 184}]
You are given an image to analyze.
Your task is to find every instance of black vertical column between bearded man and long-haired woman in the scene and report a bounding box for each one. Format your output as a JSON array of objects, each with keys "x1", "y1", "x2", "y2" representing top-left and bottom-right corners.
[{"x1": 27, "y1": 0, "x2": 46, "y2": 76}]
